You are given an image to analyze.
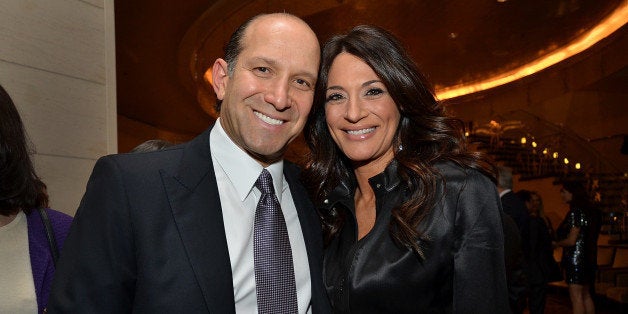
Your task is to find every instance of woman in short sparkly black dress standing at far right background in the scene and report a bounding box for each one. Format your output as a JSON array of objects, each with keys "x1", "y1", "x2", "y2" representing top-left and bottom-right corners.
[{"x1": 556, "y1": 181, "x2": 600, "y2": 314}]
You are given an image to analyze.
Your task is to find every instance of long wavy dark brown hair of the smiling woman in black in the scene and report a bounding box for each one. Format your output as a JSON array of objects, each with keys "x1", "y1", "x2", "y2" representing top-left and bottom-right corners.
[{"x1": 303, "y1": 25, "x2": 496, "y2": 256}]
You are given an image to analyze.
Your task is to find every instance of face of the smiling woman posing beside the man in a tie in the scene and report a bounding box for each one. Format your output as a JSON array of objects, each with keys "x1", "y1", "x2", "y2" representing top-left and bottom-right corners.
[{"x1": 325, "y1": 53, "x2": 401, "y2": 170}]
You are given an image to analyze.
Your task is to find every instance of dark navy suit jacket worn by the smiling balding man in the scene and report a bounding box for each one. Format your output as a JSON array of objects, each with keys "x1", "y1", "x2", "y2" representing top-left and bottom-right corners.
[{"x1": 48, "y1": 128, "x2": 330, "y2": 313}]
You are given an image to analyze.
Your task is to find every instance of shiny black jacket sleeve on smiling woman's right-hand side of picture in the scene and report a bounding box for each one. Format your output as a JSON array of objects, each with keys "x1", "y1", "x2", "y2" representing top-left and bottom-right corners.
[{"x1": 451, "y1": 172, "x2": 510, "y2": 313}]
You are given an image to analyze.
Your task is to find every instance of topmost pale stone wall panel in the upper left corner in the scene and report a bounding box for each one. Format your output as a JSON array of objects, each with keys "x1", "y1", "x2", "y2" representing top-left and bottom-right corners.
[{"x1": 0, "y1": 0, "x2": 105, "y2": 84}]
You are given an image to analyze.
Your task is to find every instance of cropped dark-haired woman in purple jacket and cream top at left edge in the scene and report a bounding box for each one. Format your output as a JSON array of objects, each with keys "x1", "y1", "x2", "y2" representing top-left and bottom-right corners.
[{"x1": 0, "y1": 86, "x2": 72, "y2": 313}]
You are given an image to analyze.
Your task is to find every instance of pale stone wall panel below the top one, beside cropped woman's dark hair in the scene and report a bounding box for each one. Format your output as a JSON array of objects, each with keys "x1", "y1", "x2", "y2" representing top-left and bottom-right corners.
[{"x1": 0, "y1": 61, "x2": 107, "y2": 159}]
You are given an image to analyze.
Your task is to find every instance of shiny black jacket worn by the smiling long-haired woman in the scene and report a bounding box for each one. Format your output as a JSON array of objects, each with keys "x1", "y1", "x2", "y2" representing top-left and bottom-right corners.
[{"x1": 324, "y1": 161, "x2": 509, "y2": 313}]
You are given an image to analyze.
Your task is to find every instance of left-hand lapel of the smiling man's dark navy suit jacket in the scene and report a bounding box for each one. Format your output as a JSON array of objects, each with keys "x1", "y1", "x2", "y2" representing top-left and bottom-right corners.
[{"x1": 161, "y1": 128, "x2": 235, "y2": 313}]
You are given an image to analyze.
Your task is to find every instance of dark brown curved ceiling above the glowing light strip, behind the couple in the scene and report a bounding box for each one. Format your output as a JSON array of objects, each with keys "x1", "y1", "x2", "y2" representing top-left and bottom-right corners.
[{"x1": 115, "y1": 0, "x2": 627, "y2": 134}]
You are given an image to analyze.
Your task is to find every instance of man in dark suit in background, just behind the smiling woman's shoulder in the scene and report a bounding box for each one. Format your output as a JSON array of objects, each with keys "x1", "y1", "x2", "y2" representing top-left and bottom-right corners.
[{"x1": 497, "y1": 166, "x2": 530, "y2": 314}]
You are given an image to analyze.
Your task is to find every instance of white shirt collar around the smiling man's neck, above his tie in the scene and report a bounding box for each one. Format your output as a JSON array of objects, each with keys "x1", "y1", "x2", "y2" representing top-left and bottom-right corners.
[{"x1": 209, "y1": 118, "x2": 284, "y2": 203}]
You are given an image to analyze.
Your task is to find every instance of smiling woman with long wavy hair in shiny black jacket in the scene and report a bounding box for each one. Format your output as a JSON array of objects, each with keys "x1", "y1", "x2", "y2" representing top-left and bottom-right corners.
[{"x1": 303, "y1": 26, "x2": 508, "y2": 313}]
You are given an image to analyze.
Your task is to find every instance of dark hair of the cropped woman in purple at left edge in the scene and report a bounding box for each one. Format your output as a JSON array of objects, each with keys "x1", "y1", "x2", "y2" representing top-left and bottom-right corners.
[{"x1": 0, "y1": 86, "x2": 48, "y2": 216}]
